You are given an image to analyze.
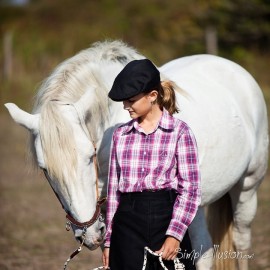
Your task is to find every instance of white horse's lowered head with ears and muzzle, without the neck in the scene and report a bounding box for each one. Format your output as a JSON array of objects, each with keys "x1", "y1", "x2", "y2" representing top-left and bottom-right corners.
[{"x1": 5, "y1": 90, "x2": 108, "y2": 249}]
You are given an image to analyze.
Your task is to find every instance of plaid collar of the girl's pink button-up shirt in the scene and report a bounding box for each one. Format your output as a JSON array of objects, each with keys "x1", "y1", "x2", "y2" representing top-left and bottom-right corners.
[{"x1": 123, "y1": 108, "x2": 175, "y2": 133}]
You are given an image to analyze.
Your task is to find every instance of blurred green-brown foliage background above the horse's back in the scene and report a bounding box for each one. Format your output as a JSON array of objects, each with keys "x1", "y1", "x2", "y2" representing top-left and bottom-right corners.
[{"x1": 0, "y1": 0, "x2": 270, "y2": 110}]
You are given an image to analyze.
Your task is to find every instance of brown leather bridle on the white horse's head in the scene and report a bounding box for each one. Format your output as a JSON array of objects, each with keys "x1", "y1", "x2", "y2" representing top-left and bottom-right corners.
[{"x1": 43, "y1": 104, "x2": 107, "y2": 270}]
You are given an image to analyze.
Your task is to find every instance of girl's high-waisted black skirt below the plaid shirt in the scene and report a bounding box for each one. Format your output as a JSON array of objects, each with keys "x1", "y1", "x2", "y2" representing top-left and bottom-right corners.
[{"x1": 109, "y1": 190, "x2": 196, "y2": 270}]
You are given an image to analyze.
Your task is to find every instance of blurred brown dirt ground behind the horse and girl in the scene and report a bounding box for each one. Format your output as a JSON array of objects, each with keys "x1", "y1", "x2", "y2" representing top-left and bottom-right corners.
[{"x1": 0, "y1": 113, "x2": 270, "y2": 270}]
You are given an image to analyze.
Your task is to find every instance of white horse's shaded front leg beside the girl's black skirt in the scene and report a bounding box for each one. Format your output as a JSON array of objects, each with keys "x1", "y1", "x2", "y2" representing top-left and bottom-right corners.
[{"x1": 188, "y1": 207, "x2": 213, "y2": 270}]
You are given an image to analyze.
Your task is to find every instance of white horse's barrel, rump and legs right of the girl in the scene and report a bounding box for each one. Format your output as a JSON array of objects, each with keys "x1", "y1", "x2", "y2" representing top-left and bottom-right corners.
[{"x1": 161, "y1": 55, "x2": 268, "y2": 269}]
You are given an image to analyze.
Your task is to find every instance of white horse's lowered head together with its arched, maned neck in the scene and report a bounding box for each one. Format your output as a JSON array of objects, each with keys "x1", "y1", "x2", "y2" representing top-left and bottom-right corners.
[{"x1": 6, "y1": 41, "x2": 144, "y2": 249}]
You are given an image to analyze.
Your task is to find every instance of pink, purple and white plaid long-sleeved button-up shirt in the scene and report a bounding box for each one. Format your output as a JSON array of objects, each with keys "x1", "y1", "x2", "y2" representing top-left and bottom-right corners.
[{"x1": 105, "y1": 109, "x2": 201, "y2": 247}]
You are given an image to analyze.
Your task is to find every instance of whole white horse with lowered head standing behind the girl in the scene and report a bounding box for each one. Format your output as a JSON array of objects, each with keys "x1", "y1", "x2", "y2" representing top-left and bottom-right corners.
[{"x1": 6, "y1": 41, "x2": 268, "y2": 270}]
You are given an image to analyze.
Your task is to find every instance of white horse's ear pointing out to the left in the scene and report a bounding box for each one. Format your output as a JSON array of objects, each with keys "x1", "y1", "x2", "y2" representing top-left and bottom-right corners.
[{"x1": 5, "y1": 103, "x2": 39, "y2": 131}]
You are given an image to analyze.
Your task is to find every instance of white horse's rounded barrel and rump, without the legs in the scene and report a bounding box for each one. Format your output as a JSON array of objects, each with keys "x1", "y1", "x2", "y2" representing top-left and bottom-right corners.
[{"x1": 161, "y1": 55, "x2": 268, "y2": 205}]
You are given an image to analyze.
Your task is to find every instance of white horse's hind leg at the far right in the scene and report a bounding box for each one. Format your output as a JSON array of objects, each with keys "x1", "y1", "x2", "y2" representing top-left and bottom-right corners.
[{"x1": 230, "y1": 180, "x2": 257, "y2": 270}]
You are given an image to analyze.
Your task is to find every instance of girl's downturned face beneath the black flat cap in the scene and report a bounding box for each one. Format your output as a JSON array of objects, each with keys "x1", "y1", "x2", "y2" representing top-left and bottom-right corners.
[{"x1": 123, "y1": 91, "x2": 156, "y2": 119}]
